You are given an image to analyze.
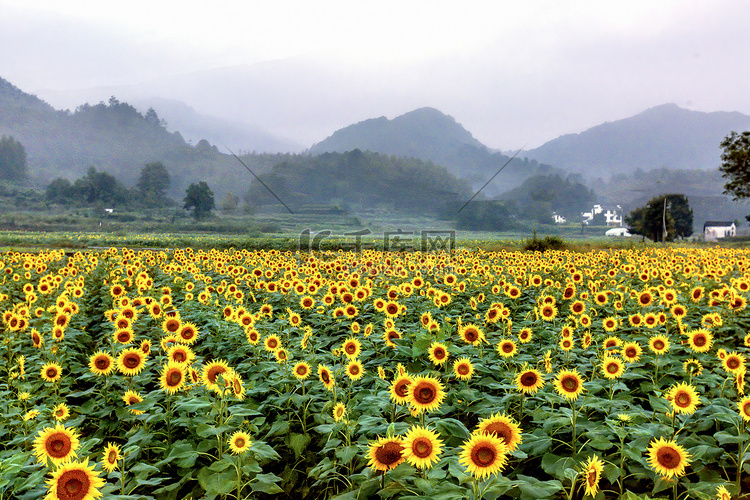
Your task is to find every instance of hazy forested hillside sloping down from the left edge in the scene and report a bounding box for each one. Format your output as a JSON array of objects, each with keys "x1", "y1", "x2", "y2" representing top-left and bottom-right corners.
[{"x1": 0, "y1": 78, "x2": 294, "y2": 199}]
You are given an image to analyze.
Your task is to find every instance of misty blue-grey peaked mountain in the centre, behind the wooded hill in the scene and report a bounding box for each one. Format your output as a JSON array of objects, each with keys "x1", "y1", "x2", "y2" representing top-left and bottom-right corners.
[{"x1": 310, "y1": 108, "x2": 561, "y2": 195}]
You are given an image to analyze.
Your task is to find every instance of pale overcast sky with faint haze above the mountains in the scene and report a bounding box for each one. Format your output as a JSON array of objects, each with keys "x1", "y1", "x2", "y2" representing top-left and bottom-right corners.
[{"x1": 0, "y1": 0, "x2": 750, "y2": 150}]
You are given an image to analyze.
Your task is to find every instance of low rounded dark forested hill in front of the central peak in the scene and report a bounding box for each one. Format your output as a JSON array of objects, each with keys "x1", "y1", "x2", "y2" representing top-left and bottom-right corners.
[{"x1": 245, "y1": 149, "x2": 471, "y2": 212}]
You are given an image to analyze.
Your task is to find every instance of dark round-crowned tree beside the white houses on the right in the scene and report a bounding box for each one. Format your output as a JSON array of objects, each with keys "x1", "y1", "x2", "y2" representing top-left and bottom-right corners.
[{"x1": 625, "y1": 194, "x2": 693, "y2": 241}]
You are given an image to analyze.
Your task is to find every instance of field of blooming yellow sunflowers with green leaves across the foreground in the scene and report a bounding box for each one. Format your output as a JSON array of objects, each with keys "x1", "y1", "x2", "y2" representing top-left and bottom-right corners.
[{"x1": 0, "y1": 247, "x2": 750, "y2": 500}]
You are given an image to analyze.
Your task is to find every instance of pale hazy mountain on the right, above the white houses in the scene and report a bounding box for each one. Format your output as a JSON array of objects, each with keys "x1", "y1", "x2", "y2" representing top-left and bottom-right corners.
[{"x1": 524, "y1": 104, "x2": 750, "y2": 178}]
